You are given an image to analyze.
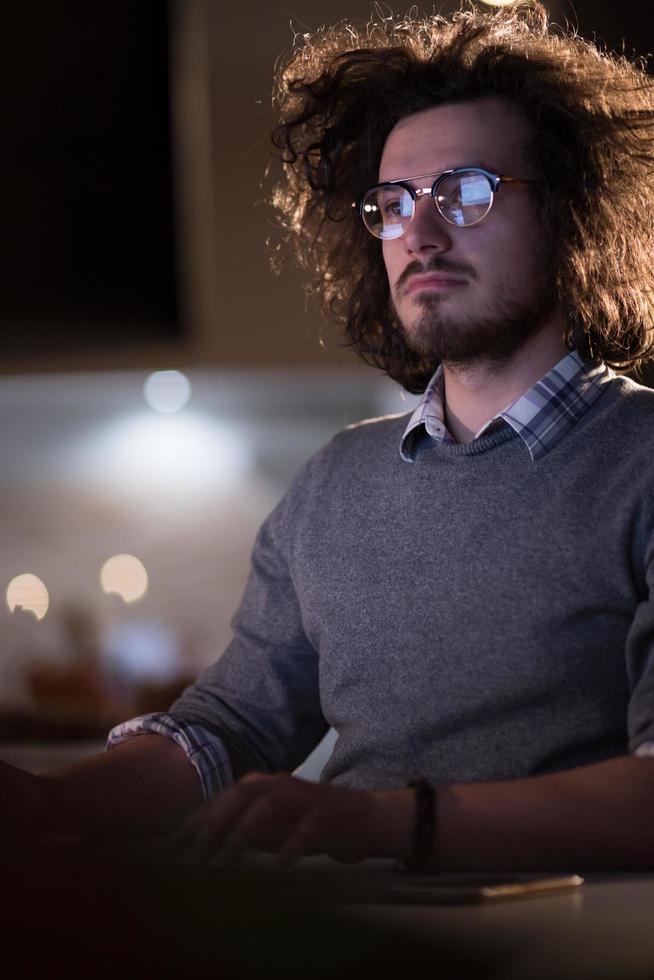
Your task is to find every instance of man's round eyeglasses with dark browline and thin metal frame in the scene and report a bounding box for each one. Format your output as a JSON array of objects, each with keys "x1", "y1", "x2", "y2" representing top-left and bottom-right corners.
[{"x1": 352, "y1": 167, "x2": 535, "y2": 240}]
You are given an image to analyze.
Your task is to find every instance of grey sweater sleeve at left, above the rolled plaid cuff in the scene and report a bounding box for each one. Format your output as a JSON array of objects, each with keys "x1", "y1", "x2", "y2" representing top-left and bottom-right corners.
[{"x1": 170, "y1": 487, "x2": 329, "y2": 777}]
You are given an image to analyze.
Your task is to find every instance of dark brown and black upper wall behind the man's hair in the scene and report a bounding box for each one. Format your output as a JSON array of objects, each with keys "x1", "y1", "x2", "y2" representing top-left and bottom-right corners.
[{"x1": 0, "y1": 0, "x2": 654, "y2": 371}]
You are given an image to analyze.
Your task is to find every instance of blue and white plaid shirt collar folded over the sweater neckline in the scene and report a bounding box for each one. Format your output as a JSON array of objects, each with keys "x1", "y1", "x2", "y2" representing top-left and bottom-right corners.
[{"x1": 400, "y1": 351, "x2": 614, "y2": 463}]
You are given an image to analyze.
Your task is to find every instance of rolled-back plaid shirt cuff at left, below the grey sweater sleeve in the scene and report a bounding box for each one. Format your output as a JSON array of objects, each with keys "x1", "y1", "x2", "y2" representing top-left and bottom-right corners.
[{"x1": 107, "y1": 714, "x2": 234, "y2": 800}]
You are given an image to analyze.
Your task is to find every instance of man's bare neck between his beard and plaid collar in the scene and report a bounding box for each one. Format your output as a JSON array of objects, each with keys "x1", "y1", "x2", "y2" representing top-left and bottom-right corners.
[{"x1": 443, "y1": 329, "x2": 568, "y2": 443}]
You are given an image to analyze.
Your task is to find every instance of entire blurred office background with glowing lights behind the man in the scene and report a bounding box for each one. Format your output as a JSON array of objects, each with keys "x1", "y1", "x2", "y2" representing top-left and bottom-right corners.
[{"x1": 0, "y1": 0, "x2": 654, "y2": 771}]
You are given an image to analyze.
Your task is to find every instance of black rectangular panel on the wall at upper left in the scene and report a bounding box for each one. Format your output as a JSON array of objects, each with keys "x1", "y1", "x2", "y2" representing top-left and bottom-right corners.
[{"x1": 0, "y1": 0, "x2": 181, "y2": 358}]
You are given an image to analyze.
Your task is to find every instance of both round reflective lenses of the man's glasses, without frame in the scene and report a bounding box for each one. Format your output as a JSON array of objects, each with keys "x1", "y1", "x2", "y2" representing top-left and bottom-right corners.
[{"x1": 361, "y1": 171, "x2": 493, "y2": 239}]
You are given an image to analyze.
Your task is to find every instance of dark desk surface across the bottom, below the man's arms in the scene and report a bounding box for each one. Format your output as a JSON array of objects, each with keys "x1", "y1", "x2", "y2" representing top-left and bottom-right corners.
[{"x1": 0, "y1": 845, "x2": 654, "y2": 980}]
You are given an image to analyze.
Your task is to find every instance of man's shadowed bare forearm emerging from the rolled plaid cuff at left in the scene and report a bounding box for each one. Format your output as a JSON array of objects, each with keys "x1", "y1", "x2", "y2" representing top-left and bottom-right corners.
[{"x1": 40, "y1": 735, "x2": 203, "y2": 838}]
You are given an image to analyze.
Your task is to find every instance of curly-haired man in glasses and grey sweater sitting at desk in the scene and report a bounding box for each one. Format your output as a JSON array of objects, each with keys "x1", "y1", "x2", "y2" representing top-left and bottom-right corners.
[{"x1": 2, "y1": 2, "x2": 654, "y2": 868}]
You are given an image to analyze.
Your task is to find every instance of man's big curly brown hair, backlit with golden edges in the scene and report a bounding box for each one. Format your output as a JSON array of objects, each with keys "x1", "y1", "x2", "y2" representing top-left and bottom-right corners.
[{"x1": 273, "y1": 0, "x2": 654, "y2": 392}]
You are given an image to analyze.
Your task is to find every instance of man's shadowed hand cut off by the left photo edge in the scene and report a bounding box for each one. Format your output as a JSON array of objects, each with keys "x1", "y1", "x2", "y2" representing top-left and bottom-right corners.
[{"x1": 0, "y1": 762, "x2": 54, "y2": 846}]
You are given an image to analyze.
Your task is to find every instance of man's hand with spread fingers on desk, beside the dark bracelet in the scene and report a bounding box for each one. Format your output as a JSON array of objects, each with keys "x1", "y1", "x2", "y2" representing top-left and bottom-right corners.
[{"x1": 172, "y1": 773, "x2": 414, "y2": 865}]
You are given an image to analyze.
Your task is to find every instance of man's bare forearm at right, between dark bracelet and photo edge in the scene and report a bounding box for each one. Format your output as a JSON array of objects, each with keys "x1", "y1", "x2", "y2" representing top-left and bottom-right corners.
[{"x1": 433, "y1": 757, "x2": 654, "y2": 870}]
